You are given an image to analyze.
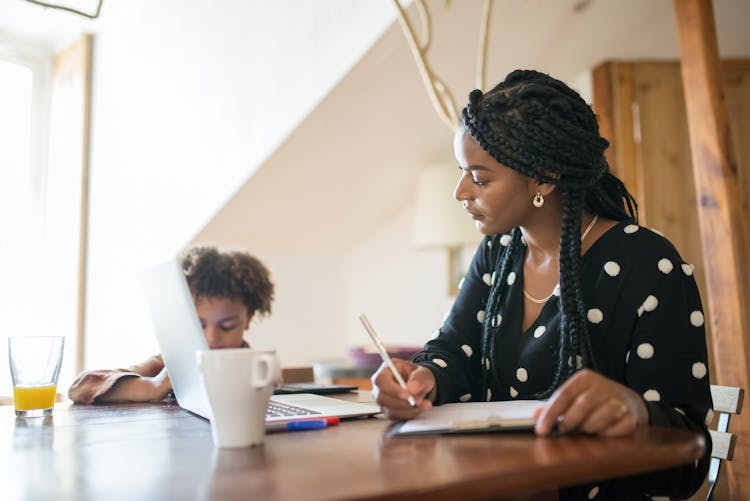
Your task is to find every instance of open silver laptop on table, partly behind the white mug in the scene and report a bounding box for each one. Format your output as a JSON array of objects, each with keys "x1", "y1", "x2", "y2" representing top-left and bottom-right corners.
[{"x1": 140, "y1": 258, "x2": 381, "y2": 423}]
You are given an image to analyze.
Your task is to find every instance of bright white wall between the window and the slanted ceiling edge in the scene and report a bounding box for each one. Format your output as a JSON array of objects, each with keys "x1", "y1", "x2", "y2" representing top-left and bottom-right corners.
[{"x1": 86, "y1": 0, "x2": 393, "y2": 367}]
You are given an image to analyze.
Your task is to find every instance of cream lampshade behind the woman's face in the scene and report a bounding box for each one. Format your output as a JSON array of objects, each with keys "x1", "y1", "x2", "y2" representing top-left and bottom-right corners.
[{"x1": 412, "y1": 164, "x2": 482, "y2": 249}]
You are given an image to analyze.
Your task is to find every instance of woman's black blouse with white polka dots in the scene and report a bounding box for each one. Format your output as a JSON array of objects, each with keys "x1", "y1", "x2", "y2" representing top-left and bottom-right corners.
[{"x1": 412, "y1": 222, "x2": 711, "y2": 499}]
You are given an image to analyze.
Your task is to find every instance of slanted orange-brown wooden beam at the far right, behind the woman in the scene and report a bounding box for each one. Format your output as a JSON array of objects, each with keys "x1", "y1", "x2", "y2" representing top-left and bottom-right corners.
[{"x1": 674, "y1": 0, "x2": 750, "y2": 499}]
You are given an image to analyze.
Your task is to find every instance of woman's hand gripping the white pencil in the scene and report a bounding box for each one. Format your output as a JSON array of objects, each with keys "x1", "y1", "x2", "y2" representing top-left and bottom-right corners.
[{"x1": 371, "y1": 359, "x2": 435, "y2": 420}]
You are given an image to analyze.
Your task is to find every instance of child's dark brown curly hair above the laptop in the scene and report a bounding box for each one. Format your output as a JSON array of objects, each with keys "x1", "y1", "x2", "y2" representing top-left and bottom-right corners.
[{"x1": 181, "y1": 246, "x2": 274, "y2": 316}]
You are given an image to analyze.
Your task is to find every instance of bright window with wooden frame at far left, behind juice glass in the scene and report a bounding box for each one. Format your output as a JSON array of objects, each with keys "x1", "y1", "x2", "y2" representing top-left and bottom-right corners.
[{"x1": 0, "y1": 36, "x2": 91, "y2": 395}]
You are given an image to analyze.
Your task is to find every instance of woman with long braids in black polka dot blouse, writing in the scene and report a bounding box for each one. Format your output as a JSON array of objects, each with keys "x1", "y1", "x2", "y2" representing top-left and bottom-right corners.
[{"x1": 373, "y1": 70, "x2": 711, "y2": 499}]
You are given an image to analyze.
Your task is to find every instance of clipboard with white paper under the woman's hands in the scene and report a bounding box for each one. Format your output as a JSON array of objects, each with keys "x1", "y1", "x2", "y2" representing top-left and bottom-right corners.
[{"x1": 387, "y1": 400, "x2": 546, "y2": 438}]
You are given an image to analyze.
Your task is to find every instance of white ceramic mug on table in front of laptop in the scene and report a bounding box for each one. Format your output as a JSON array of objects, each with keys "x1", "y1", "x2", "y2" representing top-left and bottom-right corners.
[{"x1": 197, "y1": 348, "x2": 281, "y2": 447}]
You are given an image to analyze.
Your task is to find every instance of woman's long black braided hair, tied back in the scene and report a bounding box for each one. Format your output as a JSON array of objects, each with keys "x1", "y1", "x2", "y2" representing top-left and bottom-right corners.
[{"x1": 461, "y1": 70, "x2": 638, "y2": 398}]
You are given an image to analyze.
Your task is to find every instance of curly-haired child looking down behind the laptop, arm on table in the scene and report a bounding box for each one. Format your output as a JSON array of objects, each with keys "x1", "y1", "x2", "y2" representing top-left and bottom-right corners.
[{"x1": 68, "y1": 246, "x2": 274, "y2": 404}]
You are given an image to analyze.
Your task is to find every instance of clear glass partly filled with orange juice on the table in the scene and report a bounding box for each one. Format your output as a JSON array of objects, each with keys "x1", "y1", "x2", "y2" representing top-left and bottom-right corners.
[{"x1": 8, "y1": 336, "x2": 65, "y2": 418}]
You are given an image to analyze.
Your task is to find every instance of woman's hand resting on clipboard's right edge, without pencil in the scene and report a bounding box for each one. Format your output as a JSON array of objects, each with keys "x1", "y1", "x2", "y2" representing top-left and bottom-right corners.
[{"x1": 535, "y1": 369, "x2": 648, "y2": 436}]
